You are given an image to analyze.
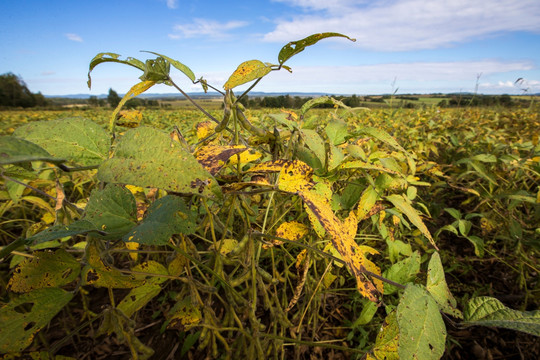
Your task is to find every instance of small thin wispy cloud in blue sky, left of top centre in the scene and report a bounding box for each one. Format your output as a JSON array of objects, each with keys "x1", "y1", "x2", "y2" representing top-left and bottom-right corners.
[{"x1": 169, "y1": 19, "x2": 248, "y2": 39}]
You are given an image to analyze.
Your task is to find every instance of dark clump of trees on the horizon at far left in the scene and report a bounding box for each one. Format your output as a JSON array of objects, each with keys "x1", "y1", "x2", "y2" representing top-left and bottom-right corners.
[{"x1": 0, "y1": 73, "x2": 48, "y2": 108}]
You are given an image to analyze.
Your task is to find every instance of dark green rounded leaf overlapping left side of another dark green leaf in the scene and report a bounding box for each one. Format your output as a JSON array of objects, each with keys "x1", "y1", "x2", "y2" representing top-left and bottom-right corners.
[{"x1": 84, "y1": 184, "x2": 137, "y2": 239}]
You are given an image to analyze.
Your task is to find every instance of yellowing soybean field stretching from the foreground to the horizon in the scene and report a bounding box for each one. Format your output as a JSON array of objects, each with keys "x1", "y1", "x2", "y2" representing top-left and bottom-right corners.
[{"x1": 0, "y1": 105, "x2": 540, "y2": 359}]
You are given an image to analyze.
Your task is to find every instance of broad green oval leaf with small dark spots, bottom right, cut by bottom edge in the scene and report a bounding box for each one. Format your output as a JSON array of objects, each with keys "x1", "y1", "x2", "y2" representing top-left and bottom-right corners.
[{"x1": 397, "y1": 284, "x2": 446, "y2": 360}]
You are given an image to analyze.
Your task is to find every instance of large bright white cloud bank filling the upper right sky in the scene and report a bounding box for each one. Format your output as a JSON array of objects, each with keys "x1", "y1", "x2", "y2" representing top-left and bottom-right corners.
[{"x1": 264, "y1": 0, "x2": 540, "y2": 51}]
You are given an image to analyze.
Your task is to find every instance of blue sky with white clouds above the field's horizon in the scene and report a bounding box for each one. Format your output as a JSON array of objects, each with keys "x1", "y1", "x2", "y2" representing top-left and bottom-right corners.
[{"x1": 0, "y1": 0, "x2": 540, "y2": 95}]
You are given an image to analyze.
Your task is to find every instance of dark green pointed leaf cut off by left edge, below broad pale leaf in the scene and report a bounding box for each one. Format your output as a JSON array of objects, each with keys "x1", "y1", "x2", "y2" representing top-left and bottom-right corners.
[{"x1": 0, "y1": 135, "x2": 65, "y2": 165}]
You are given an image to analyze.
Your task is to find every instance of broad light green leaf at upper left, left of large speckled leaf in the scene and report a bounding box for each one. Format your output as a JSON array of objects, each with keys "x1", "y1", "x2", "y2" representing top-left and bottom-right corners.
[{"x1": 13, "y1": 118, "x2": 111, "y2": 166}]
